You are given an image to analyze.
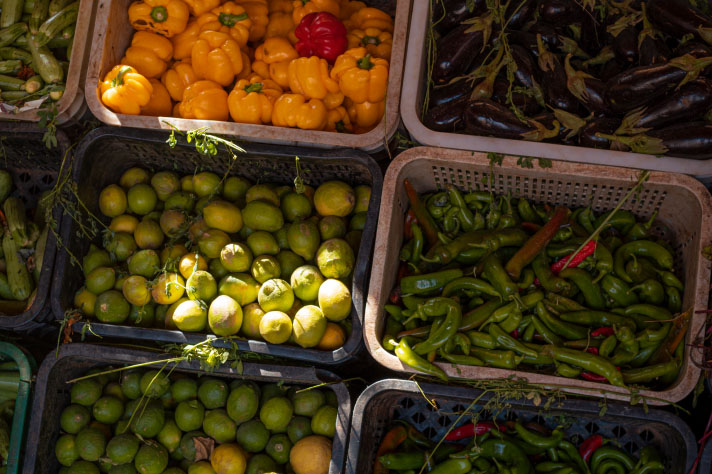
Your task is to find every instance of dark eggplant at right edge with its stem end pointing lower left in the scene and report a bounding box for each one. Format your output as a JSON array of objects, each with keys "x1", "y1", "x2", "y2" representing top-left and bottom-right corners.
[{"x1": 616, "y1": 78, "x2": 712, "y2": 135}]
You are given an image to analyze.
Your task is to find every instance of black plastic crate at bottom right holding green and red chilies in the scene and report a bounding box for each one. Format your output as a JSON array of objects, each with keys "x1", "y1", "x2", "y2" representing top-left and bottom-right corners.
[{"x1": 345, "y1": 379, "x2": 710, "y2": 474}]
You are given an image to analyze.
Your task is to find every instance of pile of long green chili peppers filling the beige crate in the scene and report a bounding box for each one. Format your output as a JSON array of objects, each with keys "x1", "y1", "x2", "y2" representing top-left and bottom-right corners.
[{"x1": 382, "y1": 180, "x2": 689, "y2": 388}]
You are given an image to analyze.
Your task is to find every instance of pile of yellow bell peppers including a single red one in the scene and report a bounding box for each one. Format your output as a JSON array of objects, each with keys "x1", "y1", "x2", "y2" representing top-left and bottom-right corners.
[{"x1": 98, "y1": 0, "x2": 393, "y2": 133}]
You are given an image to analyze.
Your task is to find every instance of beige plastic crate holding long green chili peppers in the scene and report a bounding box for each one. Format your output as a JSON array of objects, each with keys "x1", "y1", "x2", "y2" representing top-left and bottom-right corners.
[{"x1": 364, "y1": 147, "x2": 712, "y2": 404}]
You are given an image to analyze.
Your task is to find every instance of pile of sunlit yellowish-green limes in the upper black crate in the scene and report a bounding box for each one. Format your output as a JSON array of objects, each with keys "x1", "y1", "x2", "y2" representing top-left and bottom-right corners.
[{"x1": 74, "y1": 168, "x2": 371, "y2": 350}]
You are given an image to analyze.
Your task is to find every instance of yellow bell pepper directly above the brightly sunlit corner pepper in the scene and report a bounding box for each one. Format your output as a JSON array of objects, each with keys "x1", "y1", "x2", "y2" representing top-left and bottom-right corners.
[{"x1": 121, "y1": 31, "x2": 173, "y2": 77}]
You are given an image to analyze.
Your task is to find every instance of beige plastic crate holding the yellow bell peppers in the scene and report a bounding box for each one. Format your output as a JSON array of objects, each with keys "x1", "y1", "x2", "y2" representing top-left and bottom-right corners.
[{"x1": 85, "y1": 0, "x2": 408, "y2": 151}]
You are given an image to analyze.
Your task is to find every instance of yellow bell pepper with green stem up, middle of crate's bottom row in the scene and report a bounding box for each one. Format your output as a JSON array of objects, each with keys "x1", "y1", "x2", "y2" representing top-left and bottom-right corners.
[{"x1": 227, "y1": 74, "x2": 282, "y2": 125}]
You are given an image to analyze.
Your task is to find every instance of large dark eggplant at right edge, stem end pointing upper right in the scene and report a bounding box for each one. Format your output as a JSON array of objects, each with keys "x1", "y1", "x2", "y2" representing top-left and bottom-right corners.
[{"x1": 606, "y1": 55, "x2": 712, "y2": 113}]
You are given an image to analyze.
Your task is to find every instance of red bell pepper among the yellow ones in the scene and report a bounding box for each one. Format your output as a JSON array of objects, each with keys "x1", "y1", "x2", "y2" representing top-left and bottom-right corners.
[{"x1": 294, "y1": 12, "x2": 348, "y2": 63}]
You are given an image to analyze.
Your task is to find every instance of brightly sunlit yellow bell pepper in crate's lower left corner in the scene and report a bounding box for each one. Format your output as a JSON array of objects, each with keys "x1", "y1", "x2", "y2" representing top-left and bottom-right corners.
[{"x1": 99, "y1": 64, "x2": 153, "y2": 115}]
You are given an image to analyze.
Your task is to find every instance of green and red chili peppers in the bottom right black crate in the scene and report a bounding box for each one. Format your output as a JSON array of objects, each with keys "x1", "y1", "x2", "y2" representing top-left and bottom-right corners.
[{"x1": 373, "y1": 420, "x2": 665, "y2": 474}]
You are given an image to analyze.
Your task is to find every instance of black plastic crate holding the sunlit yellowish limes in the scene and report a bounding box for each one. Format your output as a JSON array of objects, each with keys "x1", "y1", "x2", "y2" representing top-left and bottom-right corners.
[{"x1": 52, "y1": 128, "x2": 383, "y2": 365}]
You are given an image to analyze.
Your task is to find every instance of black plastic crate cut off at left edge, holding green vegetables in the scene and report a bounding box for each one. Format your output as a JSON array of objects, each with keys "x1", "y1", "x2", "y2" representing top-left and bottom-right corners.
[{"x1": 0, "y1": 122, "x2": 70, "y2": 330}]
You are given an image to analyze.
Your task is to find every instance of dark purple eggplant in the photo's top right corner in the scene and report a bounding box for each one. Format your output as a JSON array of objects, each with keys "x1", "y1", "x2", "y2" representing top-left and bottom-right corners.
[{"x1": 646, "y1": 0, "x2": 712, "y2": 44}]
